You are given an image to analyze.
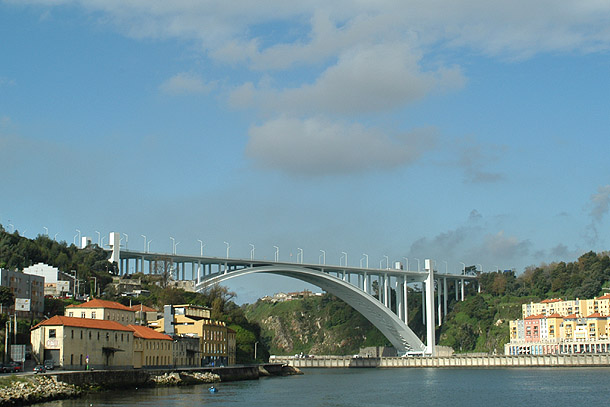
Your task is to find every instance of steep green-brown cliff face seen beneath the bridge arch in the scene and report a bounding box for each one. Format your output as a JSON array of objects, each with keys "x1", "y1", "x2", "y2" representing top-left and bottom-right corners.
[{"x1": 245, "y1": 295, "x2": 387, "y2": 355}]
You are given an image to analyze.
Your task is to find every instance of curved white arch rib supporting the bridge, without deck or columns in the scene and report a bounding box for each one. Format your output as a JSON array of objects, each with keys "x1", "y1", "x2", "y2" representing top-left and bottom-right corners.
[{"x1": 196, "y1": 265, "x2": 426, "y2": 354}]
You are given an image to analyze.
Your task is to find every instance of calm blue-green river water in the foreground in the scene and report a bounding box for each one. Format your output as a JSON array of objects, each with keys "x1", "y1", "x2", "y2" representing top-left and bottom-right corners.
[{"x1": 38, "y1": 368, "x2": 610, "y2": 407}]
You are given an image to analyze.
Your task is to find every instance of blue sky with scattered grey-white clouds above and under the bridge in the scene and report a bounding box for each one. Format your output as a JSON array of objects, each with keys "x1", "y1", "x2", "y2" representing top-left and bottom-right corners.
[{"x1": 0, "y1": 0, "x2": 610, "y2": 302}]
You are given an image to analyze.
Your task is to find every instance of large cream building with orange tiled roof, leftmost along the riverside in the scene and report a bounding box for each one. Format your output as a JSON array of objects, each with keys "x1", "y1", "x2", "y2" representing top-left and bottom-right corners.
[{"x1": 31, "y1": 315, "x2": 134, "y2": 370}]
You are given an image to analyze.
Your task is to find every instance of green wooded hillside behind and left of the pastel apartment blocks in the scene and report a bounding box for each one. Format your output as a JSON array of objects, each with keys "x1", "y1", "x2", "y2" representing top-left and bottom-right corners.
[{"x1": 437, "y1": 252, "x2": 610, "y2": 353}]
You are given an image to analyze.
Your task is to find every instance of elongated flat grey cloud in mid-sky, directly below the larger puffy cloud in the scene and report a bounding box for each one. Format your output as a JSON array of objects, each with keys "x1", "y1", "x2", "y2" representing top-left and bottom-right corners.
[{"x1": 246, "y1": 117, "x2": 436, "y2": 175}]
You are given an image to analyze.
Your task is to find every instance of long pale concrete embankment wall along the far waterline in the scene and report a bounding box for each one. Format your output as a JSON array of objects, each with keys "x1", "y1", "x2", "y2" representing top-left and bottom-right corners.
[{"x1": 273, "y1": 354, "x2": 610, "y2": 369}]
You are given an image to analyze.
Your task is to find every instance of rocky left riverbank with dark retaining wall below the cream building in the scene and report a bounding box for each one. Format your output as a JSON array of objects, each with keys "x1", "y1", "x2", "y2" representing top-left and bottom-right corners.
[{"x1": 0, "y1": 364, "x2": 302, "y2": 407}]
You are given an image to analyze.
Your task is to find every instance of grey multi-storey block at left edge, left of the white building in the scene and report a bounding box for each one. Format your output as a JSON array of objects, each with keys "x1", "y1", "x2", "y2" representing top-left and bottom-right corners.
[{"x1": 0, "y1": 269, "x2": 45, "y2": 318}]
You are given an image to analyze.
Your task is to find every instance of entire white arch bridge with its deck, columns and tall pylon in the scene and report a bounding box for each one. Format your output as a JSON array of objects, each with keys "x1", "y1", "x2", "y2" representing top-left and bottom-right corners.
[{"x1": 105, "y1": 239, "x2": 476, "y2": 355}]
